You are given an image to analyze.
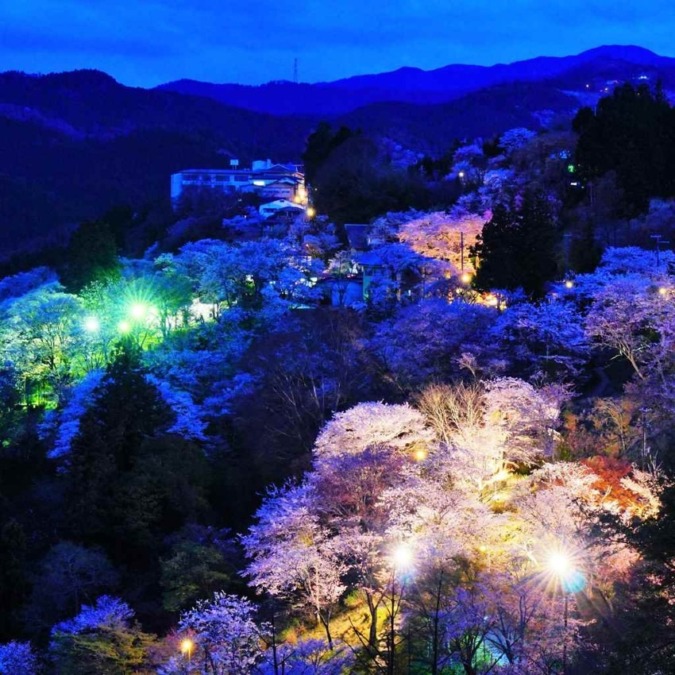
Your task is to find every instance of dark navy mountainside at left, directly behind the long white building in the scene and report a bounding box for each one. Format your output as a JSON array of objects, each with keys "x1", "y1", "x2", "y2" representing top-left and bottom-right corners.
[{"x1": 0, "y1": 71, "x2": 312, "y2": 253}]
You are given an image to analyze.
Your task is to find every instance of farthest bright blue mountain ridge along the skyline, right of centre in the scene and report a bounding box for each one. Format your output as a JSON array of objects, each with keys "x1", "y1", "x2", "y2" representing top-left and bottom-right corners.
[{"x1": 157, "y1": 46, "x2": 675, "y2": 116}]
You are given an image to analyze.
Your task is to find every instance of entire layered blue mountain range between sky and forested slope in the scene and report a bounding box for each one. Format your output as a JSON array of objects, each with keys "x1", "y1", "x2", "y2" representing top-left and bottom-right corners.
[{"x1": 0, "y1": 47, "x2": 675, "y2": 254}]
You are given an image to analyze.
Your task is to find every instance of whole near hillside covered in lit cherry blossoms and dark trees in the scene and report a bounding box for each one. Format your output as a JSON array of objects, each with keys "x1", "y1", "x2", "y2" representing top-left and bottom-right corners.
[{"x1": 0, "y1": 82, "x2": 675, "y2": 675}]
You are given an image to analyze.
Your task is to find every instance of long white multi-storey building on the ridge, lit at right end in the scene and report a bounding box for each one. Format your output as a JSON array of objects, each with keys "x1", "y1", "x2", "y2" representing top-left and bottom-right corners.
[{"x1": 171, "y1": 159, "x2": 307, "y2": 204}]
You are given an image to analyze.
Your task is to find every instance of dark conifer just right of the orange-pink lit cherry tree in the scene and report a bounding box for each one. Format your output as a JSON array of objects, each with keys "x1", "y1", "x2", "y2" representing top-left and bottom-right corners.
[{"x1": 471, "y1": 193, "x2": 558, "y2": 297}]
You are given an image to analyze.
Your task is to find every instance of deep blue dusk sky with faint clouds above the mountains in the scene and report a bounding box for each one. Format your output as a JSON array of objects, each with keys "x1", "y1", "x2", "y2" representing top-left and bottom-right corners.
[{"x1": 0, "y1": 0, "x2": 675, "y2": 86}]
